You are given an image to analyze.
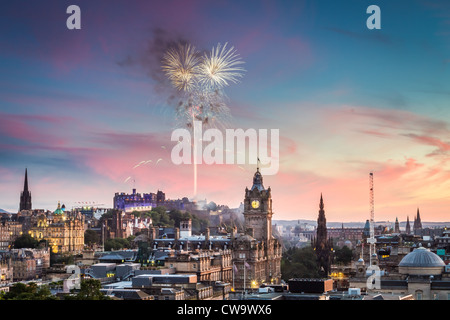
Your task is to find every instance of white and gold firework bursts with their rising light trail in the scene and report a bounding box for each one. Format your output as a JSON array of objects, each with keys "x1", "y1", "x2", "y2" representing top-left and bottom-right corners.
[{"x1": 162, "y1": 43, "x2": 245, "y2": 198}]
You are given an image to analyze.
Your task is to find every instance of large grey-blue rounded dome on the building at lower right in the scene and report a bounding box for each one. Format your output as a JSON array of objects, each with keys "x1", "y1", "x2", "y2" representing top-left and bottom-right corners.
[{"x1": 398, "y1": 247, "x2": 445, "y2": 275}]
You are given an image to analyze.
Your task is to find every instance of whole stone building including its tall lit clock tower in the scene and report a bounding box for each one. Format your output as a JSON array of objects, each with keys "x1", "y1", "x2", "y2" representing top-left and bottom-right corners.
[{"x1": 231, "y1": 168, "x2": 282, "y2": 289}]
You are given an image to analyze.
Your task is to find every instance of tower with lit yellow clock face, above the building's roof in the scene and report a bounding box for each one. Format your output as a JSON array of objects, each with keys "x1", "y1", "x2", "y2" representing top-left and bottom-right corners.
[{"x1": 244, "y1": 168, "x2": 273, "y2": 241}]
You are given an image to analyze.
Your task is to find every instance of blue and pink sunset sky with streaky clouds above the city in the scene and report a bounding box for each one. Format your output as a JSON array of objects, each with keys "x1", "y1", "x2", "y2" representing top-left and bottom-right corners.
[{"x1": 0, "y1": 0, "x2": 450, "y2": 222}]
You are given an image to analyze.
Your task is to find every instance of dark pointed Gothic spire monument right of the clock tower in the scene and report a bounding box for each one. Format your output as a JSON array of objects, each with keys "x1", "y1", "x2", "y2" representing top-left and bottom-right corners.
[{"x1": 314, "y1": 194, "x2": 332, "y2": 277}]
